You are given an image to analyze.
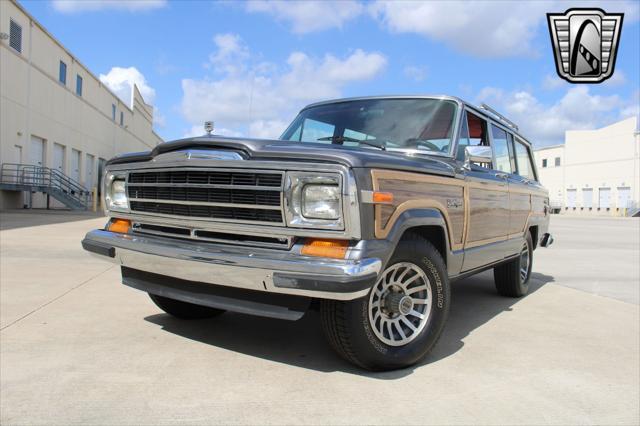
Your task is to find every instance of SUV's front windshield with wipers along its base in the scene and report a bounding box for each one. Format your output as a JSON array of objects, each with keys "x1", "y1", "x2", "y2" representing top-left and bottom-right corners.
[{"x1": 280, "y1": 99, "x2": 457, "y2": 154}]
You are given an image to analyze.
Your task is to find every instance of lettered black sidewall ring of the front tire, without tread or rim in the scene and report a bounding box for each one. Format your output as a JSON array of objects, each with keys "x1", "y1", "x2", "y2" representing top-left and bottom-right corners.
[{"x1": 350, "y1": 241, "x2": 451, "y2": 368}]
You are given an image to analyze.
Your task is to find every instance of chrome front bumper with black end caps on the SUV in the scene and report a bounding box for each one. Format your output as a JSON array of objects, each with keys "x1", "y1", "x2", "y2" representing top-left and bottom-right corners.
[{"x1": 82, "y1": 230, "x2": 382, "y2": 300}]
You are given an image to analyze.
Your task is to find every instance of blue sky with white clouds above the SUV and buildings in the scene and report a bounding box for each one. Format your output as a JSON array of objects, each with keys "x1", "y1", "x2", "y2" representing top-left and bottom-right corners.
[{"x1": 21, "y1": 0, "x2": 640, "y2": 146}]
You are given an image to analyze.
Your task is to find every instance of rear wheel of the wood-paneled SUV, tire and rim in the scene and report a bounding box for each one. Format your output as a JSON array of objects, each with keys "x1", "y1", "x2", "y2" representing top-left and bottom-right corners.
[{"x1": 493, "y1": 232, "x2": 533, "y2": 297}]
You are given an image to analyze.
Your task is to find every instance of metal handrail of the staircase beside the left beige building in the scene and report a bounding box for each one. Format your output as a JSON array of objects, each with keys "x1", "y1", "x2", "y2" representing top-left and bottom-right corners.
[{"x1": 0, "y1": 163, "x2": 91, "y2": 206}]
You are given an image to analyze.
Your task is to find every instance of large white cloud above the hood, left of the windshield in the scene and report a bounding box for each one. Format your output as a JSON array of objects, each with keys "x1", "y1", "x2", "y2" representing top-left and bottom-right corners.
[{"x1": 181, "y1": 34, "x2": 387, "y2": 138}]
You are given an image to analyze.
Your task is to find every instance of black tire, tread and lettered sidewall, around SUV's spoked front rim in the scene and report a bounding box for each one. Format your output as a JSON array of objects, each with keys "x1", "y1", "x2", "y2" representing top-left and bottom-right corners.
[{"x1": 320, "y1": 236, "x2": 451, "y2": 371}]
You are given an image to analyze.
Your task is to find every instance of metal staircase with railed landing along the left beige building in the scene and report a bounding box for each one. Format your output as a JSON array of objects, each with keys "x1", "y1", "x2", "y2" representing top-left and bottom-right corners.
[{"x1": 0, "y1": 163, "x2": 92, "y2": 210}]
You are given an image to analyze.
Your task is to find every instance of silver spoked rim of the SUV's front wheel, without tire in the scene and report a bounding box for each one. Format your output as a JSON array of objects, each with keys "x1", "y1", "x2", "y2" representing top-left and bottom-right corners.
[{"x1": 369, "y1": 262, "x2": 432, "y2": 346}]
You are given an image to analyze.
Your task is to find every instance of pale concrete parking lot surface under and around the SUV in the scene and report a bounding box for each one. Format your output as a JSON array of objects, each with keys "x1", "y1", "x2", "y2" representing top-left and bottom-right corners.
[{"x1": 0, "y1": 212, "x2": 640, "y2": 425}]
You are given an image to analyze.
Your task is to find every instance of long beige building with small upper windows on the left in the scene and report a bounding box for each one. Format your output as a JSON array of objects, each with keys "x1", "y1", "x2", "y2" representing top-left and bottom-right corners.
[{"x1": 0, "y1": 0, "x2": 162, "y2": 208}]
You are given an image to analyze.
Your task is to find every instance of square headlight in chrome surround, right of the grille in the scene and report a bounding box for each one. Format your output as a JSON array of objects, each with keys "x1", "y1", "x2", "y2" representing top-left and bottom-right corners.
[{"x1": 285, "y1": 172, "x2": 344, "y2": 230}]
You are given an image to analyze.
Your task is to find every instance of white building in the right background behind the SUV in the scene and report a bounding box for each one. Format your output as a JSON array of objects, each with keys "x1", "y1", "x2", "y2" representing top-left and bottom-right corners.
[{"x1": 535, "y1": 117, "x2": 640, "y2": 216}]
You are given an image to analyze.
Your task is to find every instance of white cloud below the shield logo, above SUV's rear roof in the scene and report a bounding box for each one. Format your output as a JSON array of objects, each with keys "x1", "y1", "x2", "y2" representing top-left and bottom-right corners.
[{"x1": 477, "y1": 86, "x2": 632, "y2": 146}]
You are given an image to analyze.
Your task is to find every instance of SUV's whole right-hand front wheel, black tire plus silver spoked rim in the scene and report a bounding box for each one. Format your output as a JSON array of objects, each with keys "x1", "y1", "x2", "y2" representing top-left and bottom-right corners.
[{"x1": 320, "y1": 236, "x2": 451, "y2": 371}]
